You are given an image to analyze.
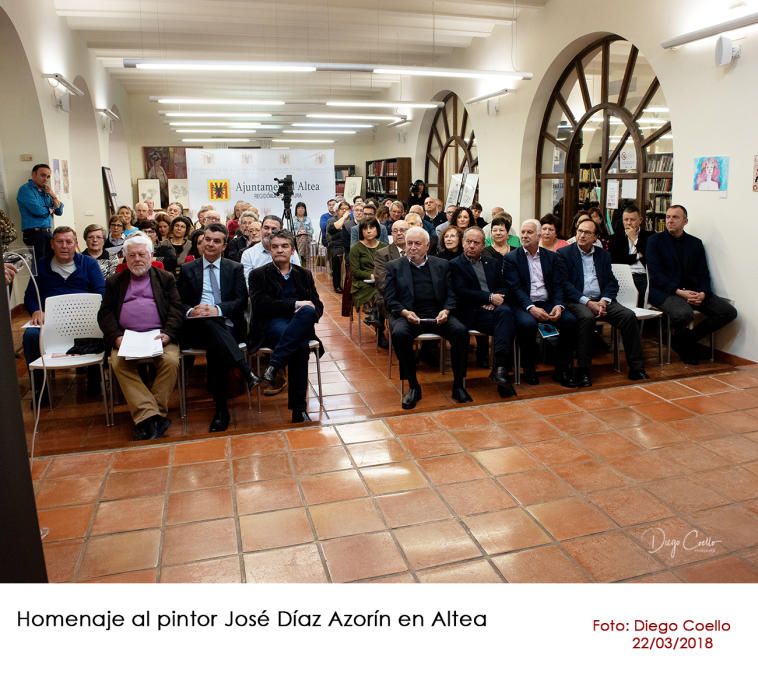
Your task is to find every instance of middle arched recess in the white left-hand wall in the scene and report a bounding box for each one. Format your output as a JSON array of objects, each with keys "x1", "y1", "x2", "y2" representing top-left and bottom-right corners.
[{"x1": 68, "y1": 75, "x2": 107, "y2": 236}]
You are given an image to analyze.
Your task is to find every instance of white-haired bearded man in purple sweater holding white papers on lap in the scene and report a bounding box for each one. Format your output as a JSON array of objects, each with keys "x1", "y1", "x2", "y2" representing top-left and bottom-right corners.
[{"x1": 97, "y1": 234, "x2": 184, "y2": 440}]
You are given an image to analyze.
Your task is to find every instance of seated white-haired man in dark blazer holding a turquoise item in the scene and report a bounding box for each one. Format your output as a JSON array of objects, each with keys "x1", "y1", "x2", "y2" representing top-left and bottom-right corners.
[{"x1": 503, "y1": 219, "x2": 576, "y2": 387}]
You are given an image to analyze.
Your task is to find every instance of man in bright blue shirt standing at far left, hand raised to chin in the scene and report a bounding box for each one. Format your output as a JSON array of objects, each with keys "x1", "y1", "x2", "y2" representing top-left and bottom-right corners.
[{"x1": 16, "y1": 163, "x2": 63, "y2": 263}]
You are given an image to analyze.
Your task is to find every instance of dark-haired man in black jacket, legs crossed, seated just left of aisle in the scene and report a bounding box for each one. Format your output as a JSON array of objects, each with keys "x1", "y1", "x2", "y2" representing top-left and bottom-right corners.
[{"x1": 248, "y1": 231, "x2": 324, "y2": 423}]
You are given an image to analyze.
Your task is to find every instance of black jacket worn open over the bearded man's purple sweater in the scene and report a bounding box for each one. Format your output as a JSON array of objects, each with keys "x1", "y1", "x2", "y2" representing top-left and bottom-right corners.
[{"x1": 97, "y1": 267, "x2": 184, "y2": 351}]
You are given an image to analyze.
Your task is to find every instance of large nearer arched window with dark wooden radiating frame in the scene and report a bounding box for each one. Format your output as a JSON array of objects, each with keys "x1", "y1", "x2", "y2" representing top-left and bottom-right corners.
[{"x1": 535, "y1": 36, "x2": 673, "y2": 237}]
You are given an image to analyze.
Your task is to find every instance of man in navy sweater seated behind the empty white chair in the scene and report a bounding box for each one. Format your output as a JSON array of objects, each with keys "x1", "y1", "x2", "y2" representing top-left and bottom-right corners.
[{"x1": 24, "y1": 226, "x2": 105, "y2": 400}]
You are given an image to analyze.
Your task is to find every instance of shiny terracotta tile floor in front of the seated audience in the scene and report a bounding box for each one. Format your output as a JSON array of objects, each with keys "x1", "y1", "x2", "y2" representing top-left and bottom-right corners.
[{"x1": 10, "y1": 270, "x2": 758, "y2": 582}]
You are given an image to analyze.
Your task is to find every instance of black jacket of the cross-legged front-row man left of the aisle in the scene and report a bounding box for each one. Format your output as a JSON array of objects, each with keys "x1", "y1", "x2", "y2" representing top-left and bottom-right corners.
[{"x1": 248, "y1": 263, "x2": 324, "y2": 355}]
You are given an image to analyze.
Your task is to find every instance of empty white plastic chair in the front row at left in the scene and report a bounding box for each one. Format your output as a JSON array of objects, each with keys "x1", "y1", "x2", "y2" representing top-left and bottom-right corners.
[{"x1": 29, "y1": 294, "x2": 113, "y2": 426}]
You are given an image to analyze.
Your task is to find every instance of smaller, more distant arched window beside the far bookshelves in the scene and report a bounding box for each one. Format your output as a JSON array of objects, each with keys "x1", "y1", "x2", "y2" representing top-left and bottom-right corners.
[{"x1": 424, "y1": 92, "x2": 479, "y2": 202}]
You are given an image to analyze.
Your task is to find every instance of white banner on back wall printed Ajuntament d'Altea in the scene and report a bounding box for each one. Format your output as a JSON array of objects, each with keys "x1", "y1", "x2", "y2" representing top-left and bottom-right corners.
[{"x1": 187, "y1": 148, "x2": 334, "y2": 221}]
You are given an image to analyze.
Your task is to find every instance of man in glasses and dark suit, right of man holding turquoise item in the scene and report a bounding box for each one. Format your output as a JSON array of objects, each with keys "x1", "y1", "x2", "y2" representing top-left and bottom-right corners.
[{"x1": 558, "y1": 219, "x2": 648, "y2": 386}]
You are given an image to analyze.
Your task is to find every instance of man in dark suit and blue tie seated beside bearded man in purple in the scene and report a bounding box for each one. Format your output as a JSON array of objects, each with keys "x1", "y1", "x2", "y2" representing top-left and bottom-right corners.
[{"x1": 179, "y1": 224, "x2": 260, "y2": 433}]
